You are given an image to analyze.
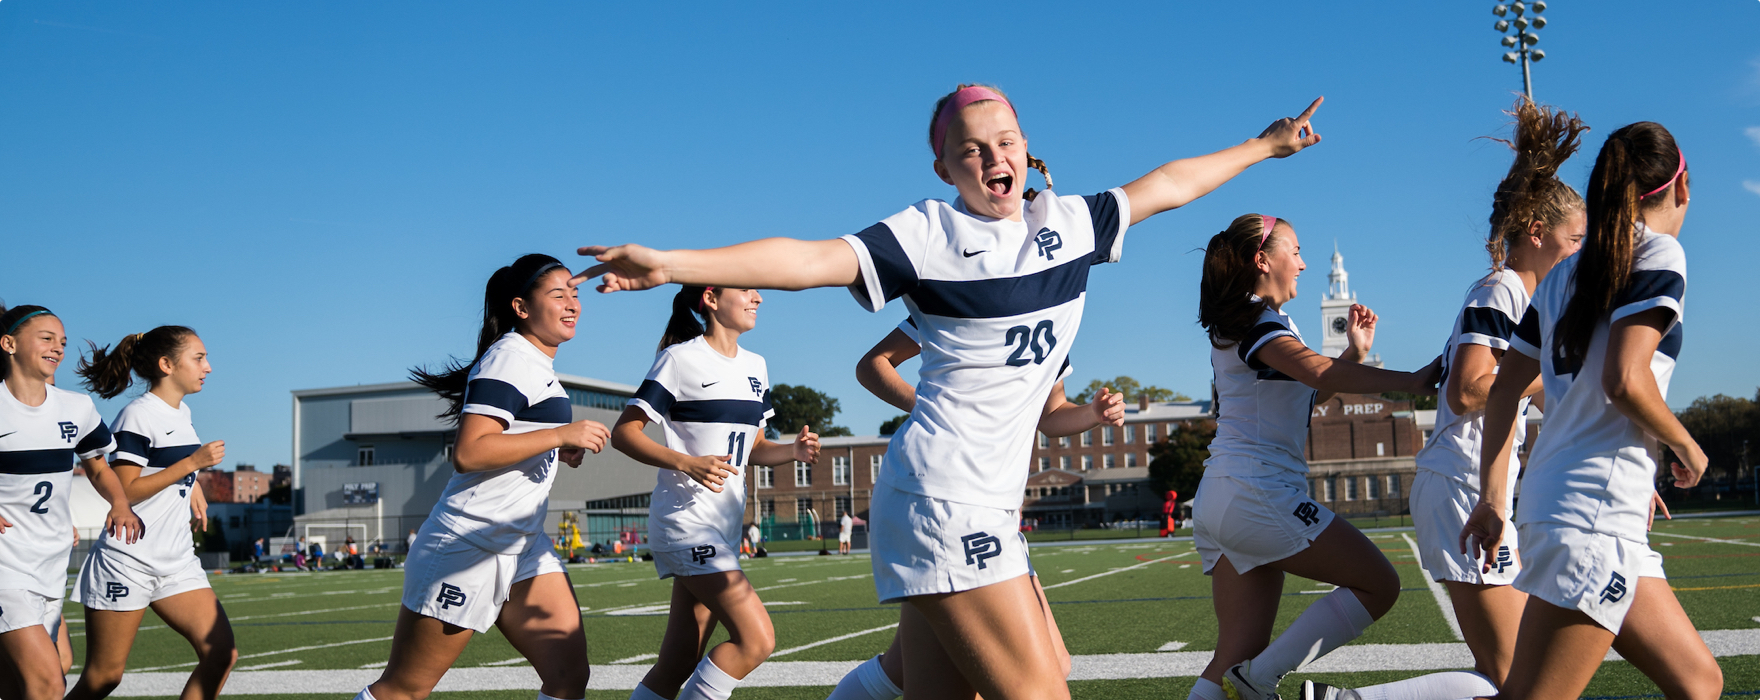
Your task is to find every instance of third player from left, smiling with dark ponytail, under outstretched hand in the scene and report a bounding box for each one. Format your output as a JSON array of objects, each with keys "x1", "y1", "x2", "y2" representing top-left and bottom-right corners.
[{"x1": 356, "y1": 253, "x2": 611, "y2": 700}]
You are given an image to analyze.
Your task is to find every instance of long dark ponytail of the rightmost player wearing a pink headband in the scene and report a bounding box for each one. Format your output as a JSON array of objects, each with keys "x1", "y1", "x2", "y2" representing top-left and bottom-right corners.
[{"x1": 1556, "y1": 121, "x2": 1686, "y2": 361}]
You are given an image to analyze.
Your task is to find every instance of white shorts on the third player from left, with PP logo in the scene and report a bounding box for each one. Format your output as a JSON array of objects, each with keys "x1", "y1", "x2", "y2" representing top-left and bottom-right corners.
[{"x1": 403, "y1": 519, "x2": 567, "y2": 631}]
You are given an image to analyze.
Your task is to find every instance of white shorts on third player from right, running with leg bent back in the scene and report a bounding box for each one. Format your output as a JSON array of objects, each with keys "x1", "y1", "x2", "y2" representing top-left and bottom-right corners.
[{"x1": 1192, "y1": 471, "x2": 1332, "y2": 573}]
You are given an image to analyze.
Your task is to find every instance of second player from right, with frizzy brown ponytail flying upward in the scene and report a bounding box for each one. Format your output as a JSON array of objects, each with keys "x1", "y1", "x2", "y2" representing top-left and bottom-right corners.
[{"x1": 1302, "y1": 97, "x2": 1589, "y2": 700}]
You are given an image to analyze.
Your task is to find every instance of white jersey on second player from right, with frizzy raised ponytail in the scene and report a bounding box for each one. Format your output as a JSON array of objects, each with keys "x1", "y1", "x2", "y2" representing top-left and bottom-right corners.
[{"x1": 1417, "y1": 267, "x2": 1528, "y2": 499}]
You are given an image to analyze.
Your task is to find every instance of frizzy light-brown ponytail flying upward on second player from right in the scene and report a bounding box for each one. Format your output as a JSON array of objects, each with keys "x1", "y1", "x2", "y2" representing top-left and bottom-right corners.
[{"x1": 1485, "y1": 97, "x2": 1589, "y2": 269}]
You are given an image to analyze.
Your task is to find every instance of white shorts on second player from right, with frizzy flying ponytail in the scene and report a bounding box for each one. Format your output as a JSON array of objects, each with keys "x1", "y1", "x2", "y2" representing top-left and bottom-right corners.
[{"x1": 1412, "y1": 470, "x2": 1522, "y2": 586}]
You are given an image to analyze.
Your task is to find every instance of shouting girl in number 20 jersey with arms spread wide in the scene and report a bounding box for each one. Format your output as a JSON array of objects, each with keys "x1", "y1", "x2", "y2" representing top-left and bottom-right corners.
[{"x1": 576, "y1": 86, "x2": 1320, "y2": 700}]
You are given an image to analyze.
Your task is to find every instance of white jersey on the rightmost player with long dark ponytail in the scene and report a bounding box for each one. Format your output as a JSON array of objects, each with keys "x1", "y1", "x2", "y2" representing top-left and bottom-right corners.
[{"x1": 1512, "y1": 223, "x2": 1686, "y2": 542}]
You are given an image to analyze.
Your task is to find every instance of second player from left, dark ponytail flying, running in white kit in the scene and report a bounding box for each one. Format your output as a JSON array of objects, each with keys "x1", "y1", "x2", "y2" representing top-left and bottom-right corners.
[{"x1": 67, "y1": 325, "x2": 238, "y2": 700}]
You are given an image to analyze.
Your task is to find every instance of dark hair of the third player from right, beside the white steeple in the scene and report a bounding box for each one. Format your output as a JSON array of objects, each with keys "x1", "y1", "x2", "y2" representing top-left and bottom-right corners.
[{"x1": 1199, "y1": 215, "x2": 1290, "y2": 348}]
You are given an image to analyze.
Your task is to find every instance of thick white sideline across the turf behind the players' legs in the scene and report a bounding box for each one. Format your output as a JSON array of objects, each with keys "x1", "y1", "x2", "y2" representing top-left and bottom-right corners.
[{"x1": 85, "y1": 628, "x2": 1760, "y2": 696}]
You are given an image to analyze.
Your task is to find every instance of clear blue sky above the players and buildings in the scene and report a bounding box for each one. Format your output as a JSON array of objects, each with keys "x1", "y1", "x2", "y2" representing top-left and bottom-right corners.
[{"x1": 0, "y1": 0, "x2": 1760, "y2": 464}]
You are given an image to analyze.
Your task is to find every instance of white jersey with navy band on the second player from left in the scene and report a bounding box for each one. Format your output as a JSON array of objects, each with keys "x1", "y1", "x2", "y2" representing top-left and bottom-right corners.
[{"x1": 93, "y1": 392, "x2": 202, "y2": 577}]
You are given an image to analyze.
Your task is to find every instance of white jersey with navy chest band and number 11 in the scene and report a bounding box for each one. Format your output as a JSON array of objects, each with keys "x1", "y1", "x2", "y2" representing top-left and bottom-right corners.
[{"x1": 628, "y1": 336, "x2": 776, "y2": 552}]
